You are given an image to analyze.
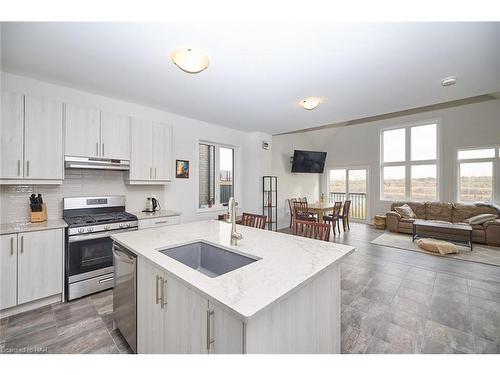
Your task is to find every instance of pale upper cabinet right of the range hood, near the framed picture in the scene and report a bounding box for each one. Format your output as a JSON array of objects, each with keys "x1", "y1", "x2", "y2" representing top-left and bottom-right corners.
[{"x1": 129, "y1": 118, "x2": 172, "y2": 184}]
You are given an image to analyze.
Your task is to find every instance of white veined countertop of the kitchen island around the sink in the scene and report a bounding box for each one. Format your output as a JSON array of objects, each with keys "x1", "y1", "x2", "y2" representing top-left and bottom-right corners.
[{"x1": 112, "y1": 220, "x2": 354, "y2": 321}]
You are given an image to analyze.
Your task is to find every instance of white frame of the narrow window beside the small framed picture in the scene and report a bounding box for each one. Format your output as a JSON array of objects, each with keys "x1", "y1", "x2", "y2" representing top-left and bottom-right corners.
[{"x1": 196, "y1": 139, "x2": 238, "y2": 213}]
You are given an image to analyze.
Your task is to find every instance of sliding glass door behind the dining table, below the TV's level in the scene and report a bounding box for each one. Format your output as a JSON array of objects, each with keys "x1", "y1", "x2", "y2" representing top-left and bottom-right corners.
[{"x1": 327, "y1": 168, "x2": 368, "y2": 221}]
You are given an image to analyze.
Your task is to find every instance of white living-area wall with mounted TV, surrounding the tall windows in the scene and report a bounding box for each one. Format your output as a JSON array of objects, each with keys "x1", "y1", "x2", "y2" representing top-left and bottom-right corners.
[{"x1": 273, "y1": 100, "x2": 500, "y2": 226}]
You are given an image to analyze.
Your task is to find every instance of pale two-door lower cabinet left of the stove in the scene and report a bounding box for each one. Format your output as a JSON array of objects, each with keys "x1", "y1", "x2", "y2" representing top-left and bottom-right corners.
[{"x1": 0, "y1": 229, "x2": 64, "y2": 309}]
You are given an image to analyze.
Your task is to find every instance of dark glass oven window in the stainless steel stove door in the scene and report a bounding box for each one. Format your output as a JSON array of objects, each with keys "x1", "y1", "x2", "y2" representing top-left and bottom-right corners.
[{"x1": 69, "y1": 237, "x2": 113, "y2": 276}]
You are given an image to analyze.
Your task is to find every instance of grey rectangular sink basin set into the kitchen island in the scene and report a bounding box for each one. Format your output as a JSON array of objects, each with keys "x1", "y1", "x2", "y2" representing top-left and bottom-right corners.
[{"x1": 160, "y1": 241, "x2": 257, "y2": 277}]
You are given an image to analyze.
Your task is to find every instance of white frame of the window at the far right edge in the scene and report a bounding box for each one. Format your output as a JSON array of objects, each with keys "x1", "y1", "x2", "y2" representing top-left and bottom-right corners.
[{"x1": 454, "y1": 144, "x2": 500, "y2": 203}]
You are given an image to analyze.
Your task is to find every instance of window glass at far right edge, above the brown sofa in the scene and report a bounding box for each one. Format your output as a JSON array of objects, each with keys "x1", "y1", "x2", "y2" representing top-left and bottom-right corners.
[{"x1": 457, "y1": 147, "x2": 500, "y2": 202}]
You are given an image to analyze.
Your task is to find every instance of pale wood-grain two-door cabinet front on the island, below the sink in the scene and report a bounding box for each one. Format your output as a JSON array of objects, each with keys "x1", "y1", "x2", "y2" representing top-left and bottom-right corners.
[{"x1": 137, "y1": 257, "x2": 243, "y2": 354}]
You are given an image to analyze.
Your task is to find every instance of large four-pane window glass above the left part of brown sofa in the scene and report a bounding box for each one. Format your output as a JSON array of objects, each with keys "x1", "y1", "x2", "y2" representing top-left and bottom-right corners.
[{"x1": 380, "y1": 124, "x2": 438, "y2": 201}]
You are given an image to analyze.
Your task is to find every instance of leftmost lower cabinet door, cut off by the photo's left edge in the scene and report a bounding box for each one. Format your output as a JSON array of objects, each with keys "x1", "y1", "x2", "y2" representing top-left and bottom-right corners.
[{"x1": 0, "y1": 234, "x2": 17, "y2": 310}]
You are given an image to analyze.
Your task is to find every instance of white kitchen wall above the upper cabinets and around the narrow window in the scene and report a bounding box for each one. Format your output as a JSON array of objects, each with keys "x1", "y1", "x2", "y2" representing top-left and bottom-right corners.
[{"x1": 0, "y1": 72, "x2": 271, "y2": 222}]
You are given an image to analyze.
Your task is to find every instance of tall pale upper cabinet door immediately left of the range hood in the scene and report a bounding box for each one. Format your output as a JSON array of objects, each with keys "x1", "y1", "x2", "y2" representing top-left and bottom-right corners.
[{"x1": 24, "y1": 96, "x2": 63, "y2": 180}]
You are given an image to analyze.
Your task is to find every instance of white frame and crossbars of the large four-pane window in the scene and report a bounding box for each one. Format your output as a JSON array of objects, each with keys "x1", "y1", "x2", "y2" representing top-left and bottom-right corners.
[{"x1": 379, "y1": 118, "x2": 442, "y2": 202}]
